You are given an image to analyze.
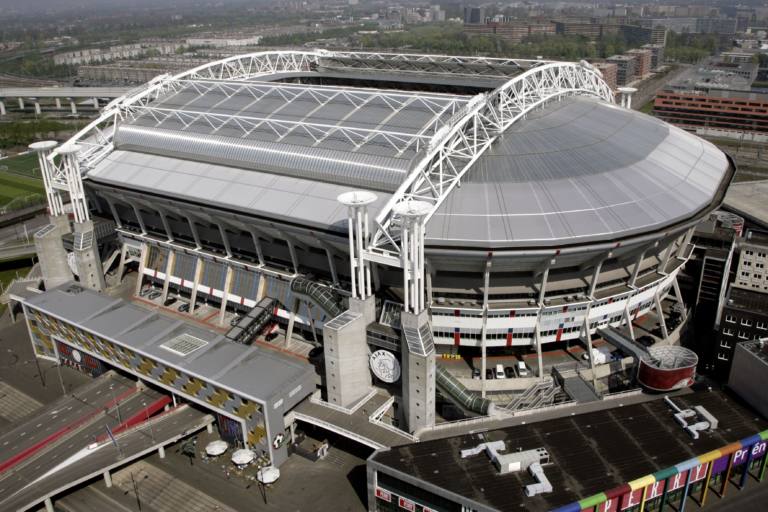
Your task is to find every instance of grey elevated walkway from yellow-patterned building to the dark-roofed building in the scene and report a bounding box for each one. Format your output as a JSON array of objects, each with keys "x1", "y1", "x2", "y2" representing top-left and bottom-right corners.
[{"x1": 286, "y1": 394, "x2": 416, "y2": 450}]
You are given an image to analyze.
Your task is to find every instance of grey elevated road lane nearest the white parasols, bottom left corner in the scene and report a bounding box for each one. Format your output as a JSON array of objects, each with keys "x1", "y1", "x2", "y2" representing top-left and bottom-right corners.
[{"x1": 0, "y1": 405, "x2": 213, "y2": 511}]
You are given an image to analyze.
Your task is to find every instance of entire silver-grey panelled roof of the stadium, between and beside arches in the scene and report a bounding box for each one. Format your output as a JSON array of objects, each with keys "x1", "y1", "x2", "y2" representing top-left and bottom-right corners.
[{"x1": 86, "y1": 54, "x2": 732, "y2": 248}]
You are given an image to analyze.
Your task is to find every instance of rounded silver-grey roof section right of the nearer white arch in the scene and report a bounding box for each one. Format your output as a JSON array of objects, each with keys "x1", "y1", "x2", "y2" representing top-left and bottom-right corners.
[{"x1": 427, "y1": 97, "x2": 730, "y2": 247}]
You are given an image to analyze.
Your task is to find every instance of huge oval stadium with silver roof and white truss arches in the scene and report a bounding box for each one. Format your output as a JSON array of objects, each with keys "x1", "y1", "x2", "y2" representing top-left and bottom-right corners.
[{"x1": 24, "y1": 51, "x2": 734, "y2": 431}]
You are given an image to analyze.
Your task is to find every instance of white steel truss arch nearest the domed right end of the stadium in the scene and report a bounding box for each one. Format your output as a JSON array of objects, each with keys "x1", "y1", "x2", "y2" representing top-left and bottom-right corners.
[{"x1": 365, "y1": 62, "x2": 614, "y2": 267}]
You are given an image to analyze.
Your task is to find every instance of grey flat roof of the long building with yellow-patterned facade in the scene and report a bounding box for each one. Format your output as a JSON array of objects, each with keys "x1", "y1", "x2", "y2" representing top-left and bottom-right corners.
[{"x1": 24, "y1": 283, "x2": 314, "y2": 403}]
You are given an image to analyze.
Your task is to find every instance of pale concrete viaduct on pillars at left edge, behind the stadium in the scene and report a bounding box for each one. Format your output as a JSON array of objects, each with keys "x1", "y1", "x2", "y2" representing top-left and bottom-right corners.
[{"x1": 0, "y1": 87, "x2": 131, "y2": 116}]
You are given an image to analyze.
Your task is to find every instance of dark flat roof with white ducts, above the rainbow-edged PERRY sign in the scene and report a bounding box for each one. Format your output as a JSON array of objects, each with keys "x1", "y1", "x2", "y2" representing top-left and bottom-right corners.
[{"x1": 370, "y1": 391, "x2": 768, "y2": 511}]
